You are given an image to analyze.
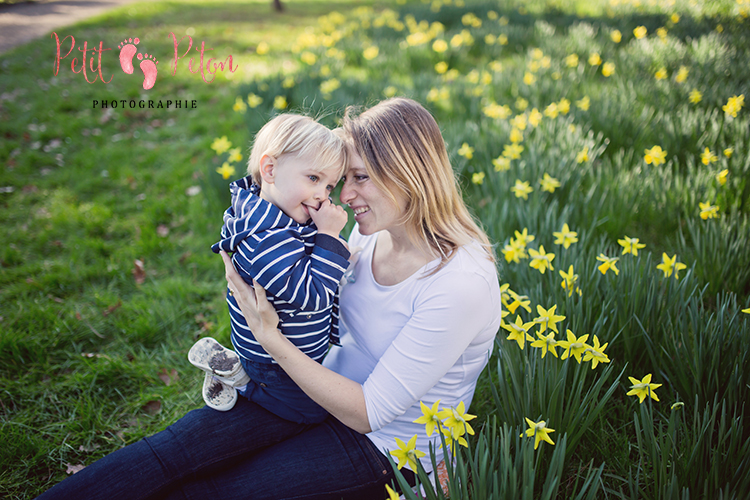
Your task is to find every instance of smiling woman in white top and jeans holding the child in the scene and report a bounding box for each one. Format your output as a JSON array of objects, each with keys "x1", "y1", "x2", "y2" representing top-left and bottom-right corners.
[{"x1": 41, "y1": 98, "x2": 500, "y2": 500}]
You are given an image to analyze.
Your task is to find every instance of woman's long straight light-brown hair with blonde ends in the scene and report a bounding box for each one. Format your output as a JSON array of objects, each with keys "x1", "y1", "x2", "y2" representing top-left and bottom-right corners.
[{"x1": 343, "y1": 97, "x2": 495, "y2": 272}]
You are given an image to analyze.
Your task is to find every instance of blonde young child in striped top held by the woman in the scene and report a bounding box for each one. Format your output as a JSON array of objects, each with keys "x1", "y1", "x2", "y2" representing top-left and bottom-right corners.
[{"x1": 188, "y1": 114, "x2": 349, "y2": 423}]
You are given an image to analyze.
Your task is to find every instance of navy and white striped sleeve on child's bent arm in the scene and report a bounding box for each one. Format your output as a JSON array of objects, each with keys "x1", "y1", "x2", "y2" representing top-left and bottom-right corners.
[{"x1": 232, "y1": 228, "x2": 348, "y2": 311}]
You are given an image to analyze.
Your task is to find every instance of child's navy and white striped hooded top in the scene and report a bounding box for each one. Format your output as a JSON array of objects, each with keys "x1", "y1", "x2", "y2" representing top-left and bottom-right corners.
[{"x1": 211, "y1": 177, "x2": 349, "y2": 363}]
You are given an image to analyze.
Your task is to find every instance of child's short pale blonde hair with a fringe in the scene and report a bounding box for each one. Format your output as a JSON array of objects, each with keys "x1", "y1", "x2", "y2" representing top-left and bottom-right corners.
[{"x1": 247, "y1": 113, "x2": 348, "y2": 185}]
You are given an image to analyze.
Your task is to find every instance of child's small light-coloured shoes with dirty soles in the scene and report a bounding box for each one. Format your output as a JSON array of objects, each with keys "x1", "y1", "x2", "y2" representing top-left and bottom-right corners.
[{"x1": 188, "y1": 337, "x2": 250, "y2": 411}]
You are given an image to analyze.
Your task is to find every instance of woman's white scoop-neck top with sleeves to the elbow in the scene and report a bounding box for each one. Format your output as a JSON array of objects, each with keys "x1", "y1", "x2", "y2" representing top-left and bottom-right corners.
[{"x1": 323, "y1": 226, "x2": 500, "y2": 472}]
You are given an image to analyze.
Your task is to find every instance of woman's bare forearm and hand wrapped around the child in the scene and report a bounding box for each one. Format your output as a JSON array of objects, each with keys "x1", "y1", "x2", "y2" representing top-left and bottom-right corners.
[{"x1": 221, "y1": 251, "x2": 371, "y2": 434}]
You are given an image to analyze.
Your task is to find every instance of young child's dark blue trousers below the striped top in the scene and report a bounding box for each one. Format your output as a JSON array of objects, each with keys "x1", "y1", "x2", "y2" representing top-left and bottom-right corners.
[{"x1": 240, "y1": 358, "x2": 328, "y2": 424}]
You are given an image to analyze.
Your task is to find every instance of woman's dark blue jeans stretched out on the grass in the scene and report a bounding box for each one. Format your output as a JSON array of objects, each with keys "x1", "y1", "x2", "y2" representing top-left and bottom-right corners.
[{"x1": 39, "y1": 398, "x2": 414, "y2": 500}]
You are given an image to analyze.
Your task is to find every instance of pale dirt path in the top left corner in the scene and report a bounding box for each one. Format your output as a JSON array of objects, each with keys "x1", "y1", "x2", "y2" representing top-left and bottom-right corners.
[{"x1": 0, "y1": 0, "x2": 142, "y2": 54}]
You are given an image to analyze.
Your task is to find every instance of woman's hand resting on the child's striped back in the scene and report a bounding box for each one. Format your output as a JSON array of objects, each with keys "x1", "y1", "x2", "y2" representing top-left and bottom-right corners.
[{"x1": 219, "y1": 250, "x2": 280, "y2": 344}]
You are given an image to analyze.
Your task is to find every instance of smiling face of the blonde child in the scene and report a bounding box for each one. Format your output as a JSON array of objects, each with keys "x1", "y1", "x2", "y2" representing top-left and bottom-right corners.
[{"x1": 260, "y1": 151, "x2": 339, "y2": 224}]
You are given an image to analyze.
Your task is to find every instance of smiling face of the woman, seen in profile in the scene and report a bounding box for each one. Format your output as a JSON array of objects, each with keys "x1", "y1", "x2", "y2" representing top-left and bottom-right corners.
[{"x1": 341, "y1": 153, "x2": 406, "y2": 235}]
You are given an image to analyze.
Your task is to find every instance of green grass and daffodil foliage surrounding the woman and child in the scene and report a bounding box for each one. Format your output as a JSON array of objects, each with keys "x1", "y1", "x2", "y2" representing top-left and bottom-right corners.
[{"x1": 0, "y1": 0, "x2": 750, "y2": 498}]
